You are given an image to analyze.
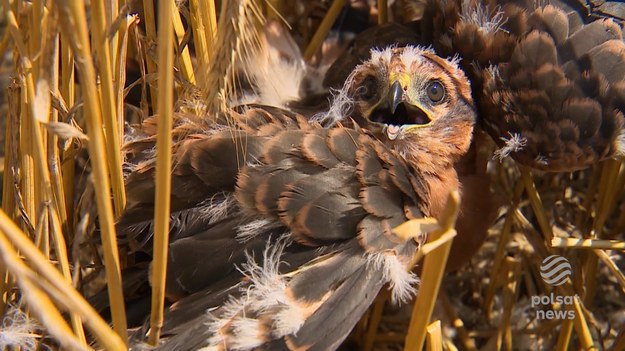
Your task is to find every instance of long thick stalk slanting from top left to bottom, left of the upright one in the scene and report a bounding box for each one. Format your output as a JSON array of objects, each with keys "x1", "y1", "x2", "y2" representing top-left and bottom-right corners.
[{"x1": 55, "y1": 1, "x2": 128, "y2": 341}]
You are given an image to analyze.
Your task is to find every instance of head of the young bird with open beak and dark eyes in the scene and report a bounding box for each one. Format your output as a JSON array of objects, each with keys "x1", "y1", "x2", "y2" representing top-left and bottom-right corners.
[{"x1": 334, "y1": 46, "x2": 476, "y2": 168}]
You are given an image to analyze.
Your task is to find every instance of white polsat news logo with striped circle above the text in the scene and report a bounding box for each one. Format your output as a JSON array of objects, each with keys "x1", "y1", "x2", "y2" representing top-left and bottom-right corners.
[{"x1": 531, "y1": 255, "x2": 577, "y2": 319}]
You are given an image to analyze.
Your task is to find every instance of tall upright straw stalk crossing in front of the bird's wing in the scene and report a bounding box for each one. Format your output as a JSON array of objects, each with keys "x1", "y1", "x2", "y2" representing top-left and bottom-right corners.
[{"x1": 148, "y1": 0, "x2": 174, "y2": 345}]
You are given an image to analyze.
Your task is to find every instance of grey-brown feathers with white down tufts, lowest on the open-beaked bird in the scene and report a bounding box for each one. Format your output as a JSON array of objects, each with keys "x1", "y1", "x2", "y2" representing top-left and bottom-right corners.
[{"x1": 134, "y1": 236, "x2": 415, "y2": 351}]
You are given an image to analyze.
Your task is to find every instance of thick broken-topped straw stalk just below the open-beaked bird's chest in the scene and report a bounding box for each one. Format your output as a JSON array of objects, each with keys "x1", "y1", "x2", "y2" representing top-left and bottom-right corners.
[{"x1": 404, "y1": 192, "x2": 460, "y2": 350}]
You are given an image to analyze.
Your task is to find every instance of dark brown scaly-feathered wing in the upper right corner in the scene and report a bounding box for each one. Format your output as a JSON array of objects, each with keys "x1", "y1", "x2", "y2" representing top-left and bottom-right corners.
[{"x1": 422, "y1": 0, "x2": 625, "y2": 171}]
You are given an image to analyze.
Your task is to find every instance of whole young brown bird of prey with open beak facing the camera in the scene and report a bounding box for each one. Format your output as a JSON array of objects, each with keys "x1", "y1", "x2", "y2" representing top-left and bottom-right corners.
[{"x1": 119, "y1": 46, "x2": 475, "y2": 350}]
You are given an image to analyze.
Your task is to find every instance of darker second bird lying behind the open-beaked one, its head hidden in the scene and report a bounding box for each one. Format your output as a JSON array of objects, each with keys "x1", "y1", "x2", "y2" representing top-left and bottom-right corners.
[{"x1": 291, "y1": 0, "x2": 625, "y2": 271}]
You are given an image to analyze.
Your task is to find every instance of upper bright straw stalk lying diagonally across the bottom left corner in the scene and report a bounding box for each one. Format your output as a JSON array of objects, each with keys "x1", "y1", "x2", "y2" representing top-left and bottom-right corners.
[{"x1": 0, "y1": 211, "x2": 126, "y2": 350}]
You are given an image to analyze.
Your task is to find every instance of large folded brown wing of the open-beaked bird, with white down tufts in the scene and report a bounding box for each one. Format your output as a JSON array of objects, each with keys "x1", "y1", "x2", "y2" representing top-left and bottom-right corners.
[{"x1": 120, "y1": 107, "x2": 430, "y2": 350}]
